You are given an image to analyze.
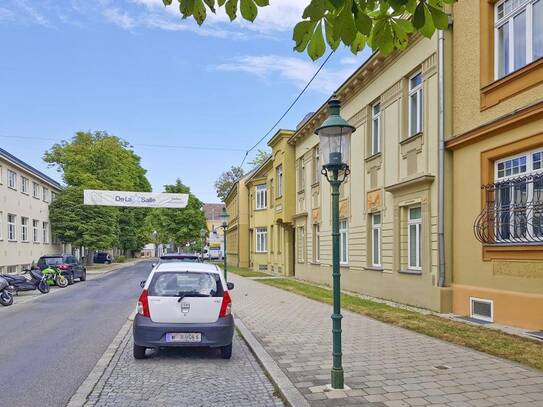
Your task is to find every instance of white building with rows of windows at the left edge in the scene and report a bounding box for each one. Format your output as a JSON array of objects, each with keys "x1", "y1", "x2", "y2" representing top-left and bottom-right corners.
[{"x1": 0, "y1": 148, "x2": 62, "y2": 273}]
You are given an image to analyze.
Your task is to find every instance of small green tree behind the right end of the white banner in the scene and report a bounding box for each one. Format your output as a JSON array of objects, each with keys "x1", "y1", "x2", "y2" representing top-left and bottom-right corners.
[{"x1": 150, "y1": 179, "x2": 207, "y2": 247}]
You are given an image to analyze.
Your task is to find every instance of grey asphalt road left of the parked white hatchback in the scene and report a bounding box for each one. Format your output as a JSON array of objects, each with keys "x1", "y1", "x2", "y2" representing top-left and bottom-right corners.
[{"x1": 0, "y1": 262, "x2": 151, "y2": 407}]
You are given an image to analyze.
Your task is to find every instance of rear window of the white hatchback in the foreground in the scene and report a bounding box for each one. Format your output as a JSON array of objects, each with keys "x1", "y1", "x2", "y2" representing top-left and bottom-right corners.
[{"x1": 149, "y1": 271, "x2": 223, "y2": 297}]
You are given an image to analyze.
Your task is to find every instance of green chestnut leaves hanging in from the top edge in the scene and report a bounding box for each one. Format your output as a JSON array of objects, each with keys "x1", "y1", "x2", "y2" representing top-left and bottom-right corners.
[{"x1": 162, "y1": 0, "x2": 456, "y2": 60}]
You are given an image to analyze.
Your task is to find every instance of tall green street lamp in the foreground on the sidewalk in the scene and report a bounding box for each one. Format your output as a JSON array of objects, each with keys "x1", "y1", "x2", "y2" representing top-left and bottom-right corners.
[{"x1": 315, "y1": 93, "x2": 356, "y2": 389}]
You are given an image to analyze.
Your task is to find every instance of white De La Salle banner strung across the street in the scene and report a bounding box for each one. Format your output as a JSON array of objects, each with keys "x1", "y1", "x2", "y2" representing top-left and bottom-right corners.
[{"x1": 83, "y1": 189, "x2": 189, "y2": 208}]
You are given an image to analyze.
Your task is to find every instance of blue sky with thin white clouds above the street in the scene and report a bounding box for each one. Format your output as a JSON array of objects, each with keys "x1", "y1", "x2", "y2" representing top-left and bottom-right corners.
[{"x1": 0, "y1": 0, "x2": 369, "y2": 202}]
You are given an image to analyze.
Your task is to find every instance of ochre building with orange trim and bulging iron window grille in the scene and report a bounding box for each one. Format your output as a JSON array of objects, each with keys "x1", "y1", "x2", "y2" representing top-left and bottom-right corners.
[{"x1": 447, "y1": 0, "x2": 543, "y2": 330}]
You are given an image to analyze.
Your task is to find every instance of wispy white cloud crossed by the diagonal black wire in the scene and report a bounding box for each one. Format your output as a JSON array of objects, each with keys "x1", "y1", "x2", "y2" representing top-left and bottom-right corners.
[{"x1": 215, "y1": 55, "x2": 353, "y2": 94}]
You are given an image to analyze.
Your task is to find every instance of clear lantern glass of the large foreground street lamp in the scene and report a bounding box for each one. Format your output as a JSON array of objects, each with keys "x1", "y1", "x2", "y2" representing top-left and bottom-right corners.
[{"x1": 319, "y1": 126, "x2": 352, "y2": 166}]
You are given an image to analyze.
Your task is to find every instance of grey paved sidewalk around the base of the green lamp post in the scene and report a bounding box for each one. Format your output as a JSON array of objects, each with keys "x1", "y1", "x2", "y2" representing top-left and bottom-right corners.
[{"x1": 229, "y1": 274, "x2": 543, "y2": 407}]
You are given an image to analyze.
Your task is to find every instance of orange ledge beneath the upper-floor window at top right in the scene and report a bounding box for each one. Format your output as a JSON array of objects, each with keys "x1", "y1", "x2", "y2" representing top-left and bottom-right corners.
[{"x1": 481, "y1": 58, "x2": 543, "y2": 111}]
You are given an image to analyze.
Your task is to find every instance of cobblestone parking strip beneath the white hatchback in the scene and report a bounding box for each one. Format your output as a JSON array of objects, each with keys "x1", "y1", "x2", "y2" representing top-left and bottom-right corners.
[{"x1": 85, "y1": 330, "x2": 283, "y2": 407}]
